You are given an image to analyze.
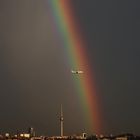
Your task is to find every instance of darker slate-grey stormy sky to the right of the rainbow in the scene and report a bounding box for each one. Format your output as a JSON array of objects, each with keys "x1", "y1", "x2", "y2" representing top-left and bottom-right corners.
[{"x1": 73, "y1": 0, "x2": 140, "y2": 134}]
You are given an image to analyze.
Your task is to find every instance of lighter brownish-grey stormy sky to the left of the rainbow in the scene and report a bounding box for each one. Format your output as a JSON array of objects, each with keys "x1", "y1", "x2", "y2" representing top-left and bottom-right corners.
[{"x1": 0, "y1": 0, "x2": 84, "y2": 135}]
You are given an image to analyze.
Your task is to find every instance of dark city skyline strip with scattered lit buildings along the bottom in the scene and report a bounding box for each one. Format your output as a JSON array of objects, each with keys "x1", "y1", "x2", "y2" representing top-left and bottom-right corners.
[{"x1": 0, "y1": 133, "x2": 140, "y2": 140}]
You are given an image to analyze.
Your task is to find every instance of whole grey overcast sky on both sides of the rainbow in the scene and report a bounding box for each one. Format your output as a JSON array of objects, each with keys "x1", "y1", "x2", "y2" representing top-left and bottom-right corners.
[{"x1": 0, "y1": 0, "x2": 140, "y2": 135}]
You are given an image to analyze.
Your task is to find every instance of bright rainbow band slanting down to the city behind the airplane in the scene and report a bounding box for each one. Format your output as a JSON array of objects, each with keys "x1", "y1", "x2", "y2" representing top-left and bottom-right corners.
[{"x1": 47, "y1": 0, "x2": 101, "y2": 134}]
